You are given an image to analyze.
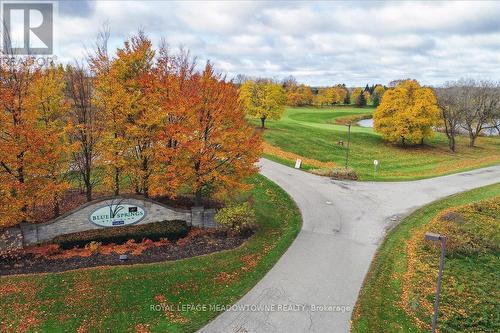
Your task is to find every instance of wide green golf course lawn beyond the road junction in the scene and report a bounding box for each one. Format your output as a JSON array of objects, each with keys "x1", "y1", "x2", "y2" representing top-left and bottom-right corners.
[{"x1": 252, "y1": 106, "x2": 500, "y2": 181}]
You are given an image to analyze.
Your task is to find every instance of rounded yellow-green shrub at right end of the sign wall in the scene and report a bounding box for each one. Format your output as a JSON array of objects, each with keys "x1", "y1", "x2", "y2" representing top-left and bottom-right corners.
[{"x1": 215, "y1": 202, "x2": 257, "y2": 234}]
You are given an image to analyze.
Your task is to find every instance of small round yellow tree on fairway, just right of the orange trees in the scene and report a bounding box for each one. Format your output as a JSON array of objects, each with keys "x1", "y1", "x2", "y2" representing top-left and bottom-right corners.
[{"x1": 240, "y1": 80, "x2": 286, "y2": 128}]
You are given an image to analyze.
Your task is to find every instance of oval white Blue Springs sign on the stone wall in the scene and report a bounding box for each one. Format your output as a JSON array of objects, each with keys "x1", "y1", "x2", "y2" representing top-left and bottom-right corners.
[{"x1": 89, "y1": 203, "x2": 146, "y2": 227}]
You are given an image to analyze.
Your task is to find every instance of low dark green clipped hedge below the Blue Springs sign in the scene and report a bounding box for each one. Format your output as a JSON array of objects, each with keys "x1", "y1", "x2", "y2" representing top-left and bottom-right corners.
[{"x1": 52, "y1": 220, "x2": 188, "y2": 249}]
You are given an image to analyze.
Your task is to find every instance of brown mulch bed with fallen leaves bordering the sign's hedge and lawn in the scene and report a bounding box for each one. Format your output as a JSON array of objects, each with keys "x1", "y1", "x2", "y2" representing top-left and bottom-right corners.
[{"x1": 0, "y1": 230, "x2": 250, "y2": 276}]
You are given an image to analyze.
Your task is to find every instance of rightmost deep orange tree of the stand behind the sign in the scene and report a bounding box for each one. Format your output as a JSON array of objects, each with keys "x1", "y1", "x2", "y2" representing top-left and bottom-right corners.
[{"x1": 181, "y1": 63, "x2": 262, "y2": 205}]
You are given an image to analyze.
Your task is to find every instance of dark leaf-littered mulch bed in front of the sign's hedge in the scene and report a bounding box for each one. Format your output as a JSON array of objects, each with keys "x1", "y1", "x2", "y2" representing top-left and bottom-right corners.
[{"x1": 0, "y1": 229, "x2": 250, "y2": 275}]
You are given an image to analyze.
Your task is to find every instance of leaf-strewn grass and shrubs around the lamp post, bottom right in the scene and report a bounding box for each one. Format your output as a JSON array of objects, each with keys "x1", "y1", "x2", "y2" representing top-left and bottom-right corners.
[{"x1": 352, "y1": 184, "x2": 500, "y2": 333}]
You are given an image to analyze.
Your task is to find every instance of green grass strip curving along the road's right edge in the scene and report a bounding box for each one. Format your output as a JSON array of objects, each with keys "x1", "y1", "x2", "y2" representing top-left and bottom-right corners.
[{"x1": 352, "y1": 184, "x2": 500, "y2": 333}]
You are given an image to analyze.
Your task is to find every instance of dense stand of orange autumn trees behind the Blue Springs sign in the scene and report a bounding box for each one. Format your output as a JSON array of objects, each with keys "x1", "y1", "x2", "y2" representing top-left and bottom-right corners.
[{"x1": 0, "y1": 32, "x2": 264, "y2": 226}]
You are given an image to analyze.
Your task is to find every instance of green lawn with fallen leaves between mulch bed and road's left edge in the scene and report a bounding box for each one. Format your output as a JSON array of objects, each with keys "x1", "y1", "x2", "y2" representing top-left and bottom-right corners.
[{"x1": 0, "y1": 175, "x2": 301, "y2": 332}]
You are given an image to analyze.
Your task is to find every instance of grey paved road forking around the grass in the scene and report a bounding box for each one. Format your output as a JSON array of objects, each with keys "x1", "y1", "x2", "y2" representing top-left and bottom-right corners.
[{"x1": 200, "y1": 159, "x2": 500, "y2": 333}]
